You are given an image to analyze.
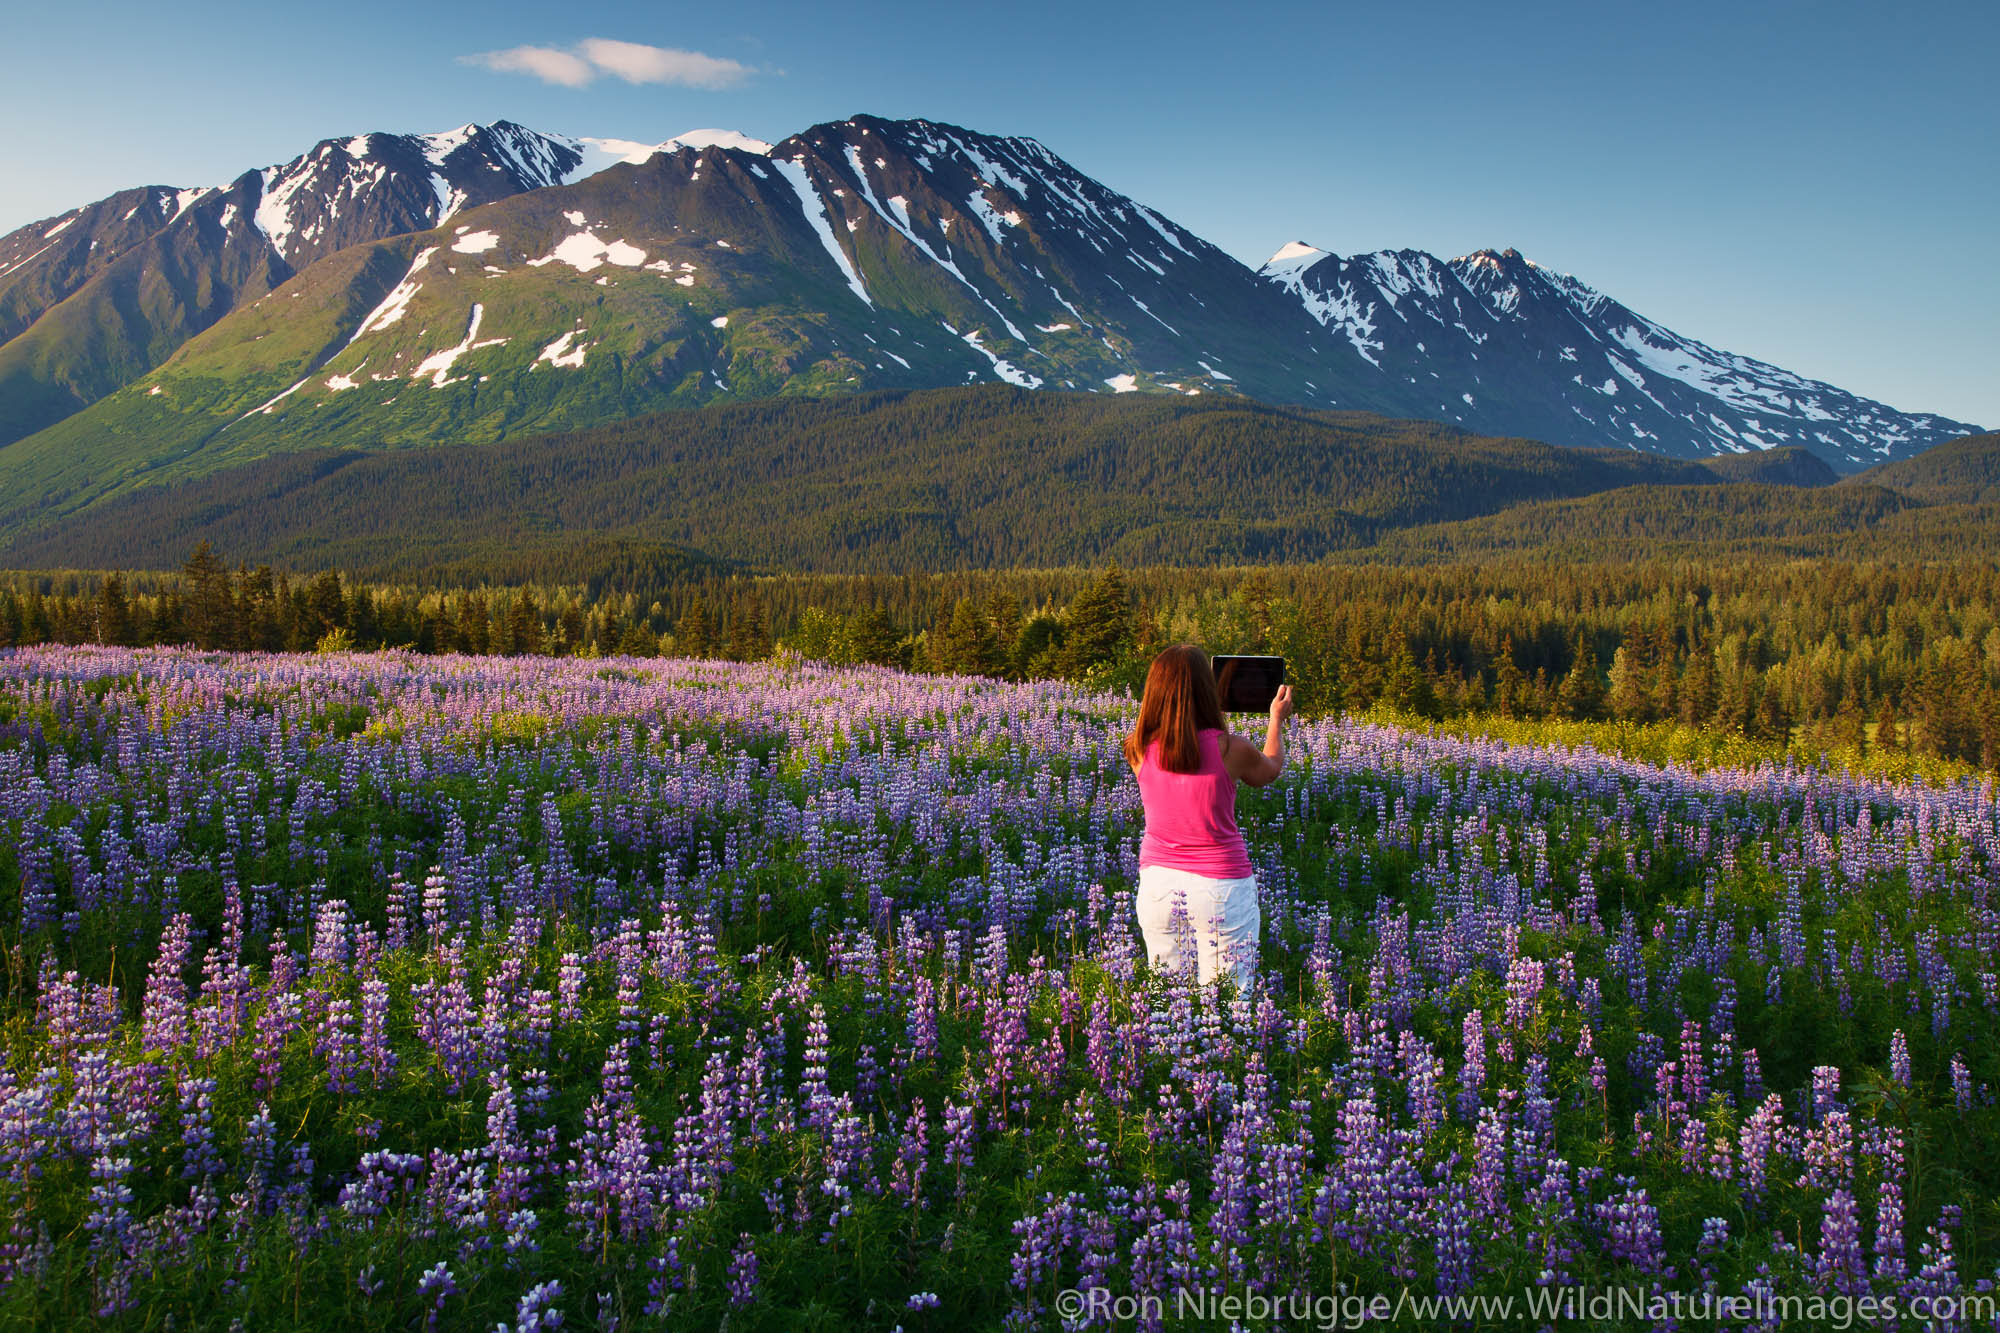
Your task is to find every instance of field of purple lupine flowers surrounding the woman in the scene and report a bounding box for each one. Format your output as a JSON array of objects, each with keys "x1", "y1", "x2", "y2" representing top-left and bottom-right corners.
[{"x1": 0, "y1": 648, "x2": 2000, "y2": 1333}]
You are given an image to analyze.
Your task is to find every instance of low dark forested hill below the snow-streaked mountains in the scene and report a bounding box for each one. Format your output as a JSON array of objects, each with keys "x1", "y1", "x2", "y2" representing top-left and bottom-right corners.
[{"x1": 0, "y1": 384, "x2": 1714, "y2": 582}]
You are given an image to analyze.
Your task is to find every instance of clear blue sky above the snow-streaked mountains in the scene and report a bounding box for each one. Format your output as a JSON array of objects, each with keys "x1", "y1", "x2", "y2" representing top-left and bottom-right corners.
[{"x1": 0, "y1": 0, "x2": 2000, "y2": 426}]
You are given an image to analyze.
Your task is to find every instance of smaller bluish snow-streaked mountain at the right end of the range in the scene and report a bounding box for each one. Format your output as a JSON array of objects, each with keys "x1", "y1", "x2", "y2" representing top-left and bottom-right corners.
[{"x1": 1258, "y1": 242, "x2": 1970, "y2": 470}]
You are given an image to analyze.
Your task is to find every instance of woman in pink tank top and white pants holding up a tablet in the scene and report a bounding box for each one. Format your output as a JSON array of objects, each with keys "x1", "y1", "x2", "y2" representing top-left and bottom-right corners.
[{"x1": 1124, "y1": 642, "x2": 1292, "y2": 989}]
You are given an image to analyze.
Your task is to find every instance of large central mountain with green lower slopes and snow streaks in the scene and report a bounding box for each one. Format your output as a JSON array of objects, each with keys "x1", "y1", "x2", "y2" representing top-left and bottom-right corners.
[{"x1": 0, "y1": 116, "x2": 1336, "y2": 522}]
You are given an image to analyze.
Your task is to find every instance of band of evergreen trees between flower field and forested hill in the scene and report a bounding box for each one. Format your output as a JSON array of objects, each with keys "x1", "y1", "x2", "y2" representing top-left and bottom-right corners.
[{"x1": 11, "y1": 542, "x2": 2000, "y2": 769}]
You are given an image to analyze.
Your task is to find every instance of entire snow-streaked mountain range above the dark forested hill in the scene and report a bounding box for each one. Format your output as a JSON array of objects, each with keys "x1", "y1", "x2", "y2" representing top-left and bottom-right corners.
[{"x1": 0, "y1": 116, "x2": 1968, "y2": 530}]
